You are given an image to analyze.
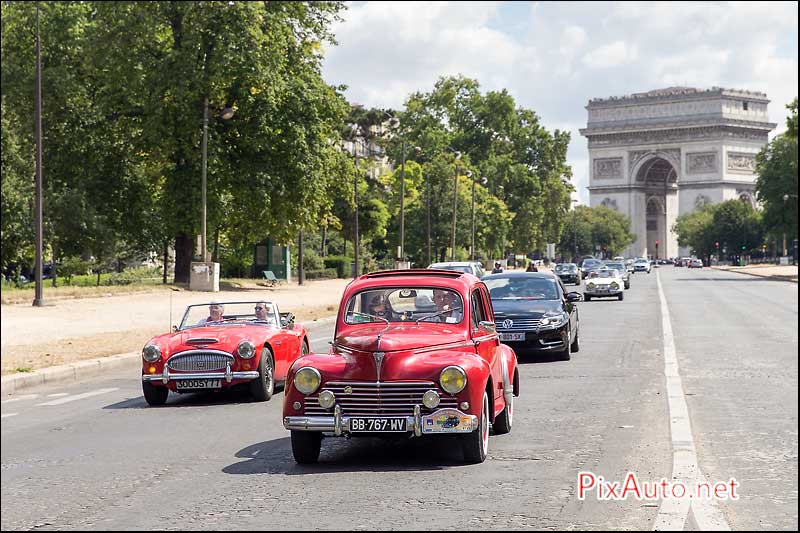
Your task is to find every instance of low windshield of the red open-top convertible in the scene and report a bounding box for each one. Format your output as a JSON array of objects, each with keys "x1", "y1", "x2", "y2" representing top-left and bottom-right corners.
[{"x1": 180, "y1": 300, "x2": 280, "y2": 329}]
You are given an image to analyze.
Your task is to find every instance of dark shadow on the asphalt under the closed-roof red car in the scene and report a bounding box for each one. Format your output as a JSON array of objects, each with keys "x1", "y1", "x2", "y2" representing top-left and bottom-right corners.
[{"x1": 222, "y1": 435, "x2": 472, "y2": 475}]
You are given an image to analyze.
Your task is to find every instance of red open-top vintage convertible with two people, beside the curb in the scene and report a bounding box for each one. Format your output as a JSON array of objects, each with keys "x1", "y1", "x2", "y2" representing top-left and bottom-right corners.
[{"x1": 142, "y1": 301, "x2": 308, "y2": 405}]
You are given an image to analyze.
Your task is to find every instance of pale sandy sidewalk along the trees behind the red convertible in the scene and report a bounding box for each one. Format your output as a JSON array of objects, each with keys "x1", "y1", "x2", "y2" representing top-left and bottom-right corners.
[{"x1": 0, "y1": 279, "x2": 350, "y2": 375}]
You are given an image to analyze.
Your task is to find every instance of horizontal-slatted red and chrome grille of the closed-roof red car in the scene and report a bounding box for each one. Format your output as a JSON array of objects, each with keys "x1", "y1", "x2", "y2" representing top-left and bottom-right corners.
[{"x1": 305, "y1": 381, "x2": 458, "y2": 416}]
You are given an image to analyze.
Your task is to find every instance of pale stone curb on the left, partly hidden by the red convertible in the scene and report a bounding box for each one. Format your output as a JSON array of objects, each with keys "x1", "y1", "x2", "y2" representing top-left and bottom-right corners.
[{"x1": 0, "y1": 316, "x2": 336, "y2": 396}]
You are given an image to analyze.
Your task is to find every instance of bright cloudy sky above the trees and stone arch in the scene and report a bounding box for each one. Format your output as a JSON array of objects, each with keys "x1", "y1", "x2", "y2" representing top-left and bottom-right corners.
[{"x1": 323, "y1": 2, "x2": 798, "y2": 205}]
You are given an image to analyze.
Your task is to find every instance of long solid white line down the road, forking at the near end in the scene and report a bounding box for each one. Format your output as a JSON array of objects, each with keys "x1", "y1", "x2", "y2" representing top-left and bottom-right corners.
[{"x1": 653, "y1": 271, "x2": 731, "y2": 531}]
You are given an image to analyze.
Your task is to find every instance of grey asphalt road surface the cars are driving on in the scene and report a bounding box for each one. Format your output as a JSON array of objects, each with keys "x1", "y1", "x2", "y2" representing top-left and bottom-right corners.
[{"x1": 2, "y1": 267, "x2": 798, "y2": 530}]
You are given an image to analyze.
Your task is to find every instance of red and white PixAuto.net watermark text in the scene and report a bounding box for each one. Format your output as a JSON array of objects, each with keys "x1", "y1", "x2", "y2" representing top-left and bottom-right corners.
[{"x1": 578, "y1": 472, "x2": 739, "y2": 501}]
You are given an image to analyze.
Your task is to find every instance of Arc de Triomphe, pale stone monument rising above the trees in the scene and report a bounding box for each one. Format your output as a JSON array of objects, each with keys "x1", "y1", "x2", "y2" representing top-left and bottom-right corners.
[{"x1": 580, "y1": 87, "x2": 776, "y2": 257}]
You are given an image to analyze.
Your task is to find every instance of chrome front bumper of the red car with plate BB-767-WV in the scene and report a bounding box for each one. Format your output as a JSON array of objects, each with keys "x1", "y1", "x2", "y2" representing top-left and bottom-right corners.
[{"x1": 283, "y1": 405, "x2": 478, "y2": 437}]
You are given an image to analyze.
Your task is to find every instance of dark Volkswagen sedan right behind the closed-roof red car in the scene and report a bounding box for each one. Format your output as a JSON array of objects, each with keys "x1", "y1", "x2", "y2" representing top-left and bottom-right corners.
[{"x1": 482, "y1": 272, "x2": 581, "y2": 360}]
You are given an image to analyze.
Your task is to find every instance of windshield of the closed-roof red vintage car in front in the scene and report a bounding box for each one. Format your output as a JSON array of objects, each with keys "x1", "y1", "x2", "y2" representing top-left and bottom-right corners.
[{"x1": 344, "y1": 286, "x2": 469, "y2": 324}]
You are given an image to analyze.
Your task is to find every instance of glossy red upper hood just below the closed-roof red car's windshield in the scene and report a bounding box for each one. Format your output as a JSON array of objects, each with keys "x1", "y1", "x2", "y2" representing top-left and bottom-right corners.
[{"x1": 336, "y1": 324, "x2": 467, "y2": 352}]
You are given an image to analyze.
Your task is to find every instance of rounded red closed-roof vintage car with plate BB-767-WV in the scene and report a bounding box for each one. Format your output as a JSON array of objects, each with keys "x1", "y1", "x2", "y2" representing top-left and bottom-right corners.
[{"x1": 283, "y1": 269, "x2": 519, "y2": 463}]
